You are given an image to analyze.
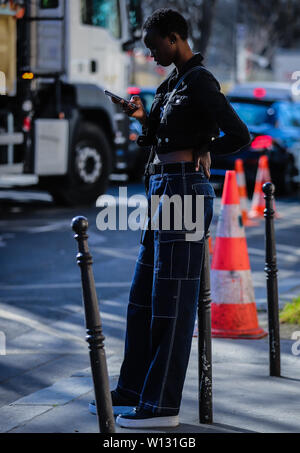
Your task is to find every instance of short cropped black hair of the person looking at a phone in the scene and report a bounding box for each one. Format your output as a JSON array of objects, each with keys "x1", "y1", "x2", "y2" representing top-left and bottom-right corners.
[{"x1": 143, "y1": 8, "x2": 188, "y2": 40}]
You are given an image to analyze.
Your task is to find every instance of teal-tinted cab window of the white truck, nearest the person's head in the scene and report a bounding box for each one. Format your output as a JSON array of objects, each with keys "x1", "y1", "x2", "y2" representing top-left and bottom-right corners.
[{"x1": 81, "y1": 0, "x2": 121, "y2": 39}]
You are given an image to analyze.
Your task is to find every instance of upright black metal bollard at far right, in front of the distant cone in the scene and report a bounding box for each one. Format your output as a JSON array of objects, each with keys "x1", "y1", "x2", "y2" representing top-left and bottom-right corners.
[{"x1": 262, "y1": 182, "x2": 280, "y2": 376}]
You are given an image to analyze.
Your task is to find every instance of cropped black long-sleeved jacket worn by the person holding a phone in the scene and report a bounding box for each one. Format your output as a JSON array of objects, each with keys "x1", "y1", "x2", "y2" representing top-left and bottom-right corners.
[{"x1": 137, "y1": 53, "x2": 251, "y2": 154}]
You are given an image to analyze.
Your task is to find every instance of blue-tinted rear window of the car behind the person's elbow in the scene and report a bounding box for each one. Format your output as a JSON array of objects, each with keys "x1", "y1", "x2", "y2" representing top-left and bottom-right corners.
[{"x1": 231, "y1": 102, "x2": 275, "y2": 126}]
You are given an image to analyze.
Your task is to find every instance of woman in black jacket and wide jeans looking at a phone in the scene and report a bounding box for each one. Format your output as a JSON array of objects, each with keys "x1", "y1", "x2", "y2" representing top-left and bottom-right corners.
[{"x1": 89, "y1": 9, "x2": 250, "y2": 428}]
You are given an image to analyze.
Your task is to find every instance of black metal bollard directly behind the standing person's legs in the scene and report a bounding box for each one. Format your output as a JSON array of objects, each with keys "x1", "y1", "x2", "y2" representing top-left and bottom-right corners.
[{"x1": 198, "y1": 232, "x2": 213, "y2": 424}]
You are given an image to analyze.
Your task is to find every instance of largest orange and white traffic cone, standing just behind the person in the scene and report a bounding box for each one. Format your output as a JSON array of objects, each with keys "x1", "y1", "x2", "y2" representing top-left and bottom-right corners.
[{"x1": 211, "y1": 170, "x2": 267, "y2": 339}]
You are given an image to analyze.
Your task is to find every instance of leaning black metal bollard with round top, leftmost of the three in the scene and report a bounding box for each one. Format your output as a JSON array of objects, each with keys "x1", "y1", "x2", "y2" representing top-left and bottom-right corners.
[{"x1": 72, "y1": 217, "x2": 115, "y2": 433}]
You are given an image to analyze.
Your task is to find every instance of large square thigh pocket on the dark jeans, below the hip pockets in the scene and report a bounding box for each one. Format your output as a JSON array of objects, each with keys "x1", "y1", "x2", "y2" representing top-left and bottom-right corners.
[{"x1": 155, "y1": 231, "x2": 204, "y2": 279}]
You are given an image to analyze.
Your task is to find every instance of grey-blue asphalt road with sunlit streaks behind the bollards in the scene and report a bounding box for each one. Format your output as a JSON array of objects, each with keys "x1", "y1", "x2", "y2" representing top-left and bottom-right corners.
[{"x1": 0, "y1": 183, "x2": 300, "y2": 407}]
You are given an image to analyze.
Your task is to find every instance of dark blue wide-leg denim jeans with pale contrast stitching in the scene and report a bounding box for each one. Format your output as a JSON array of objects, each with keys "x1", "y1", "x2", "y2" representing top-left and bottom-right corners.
[{"x1": 116, "y1": 164, "x2": 215, "y2": 416}]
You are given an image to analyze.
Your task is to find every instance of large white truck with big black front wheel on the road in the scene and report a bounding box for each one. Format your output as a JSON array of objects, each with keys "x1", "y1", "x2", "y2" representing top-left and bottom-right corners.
[{"x1": 0, "y1": 0, "x2": 141, "y2": 205}]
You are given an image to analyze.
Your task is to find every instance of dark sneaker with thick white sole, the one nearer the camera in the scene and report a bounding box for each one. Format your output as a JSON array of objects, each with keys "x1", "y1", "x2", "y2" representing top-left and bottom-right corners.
[{"x1": 116, "y1": 407, "x2": 179, "y2": 428}]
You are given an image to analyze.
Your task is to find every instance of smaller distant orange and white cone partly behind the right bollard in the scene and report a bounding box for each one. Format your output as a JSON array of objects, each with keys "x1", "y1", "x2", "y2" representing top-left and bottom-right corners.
[{"x1": 248, "y1": 155, "x2": 279, "y2": 219}]
